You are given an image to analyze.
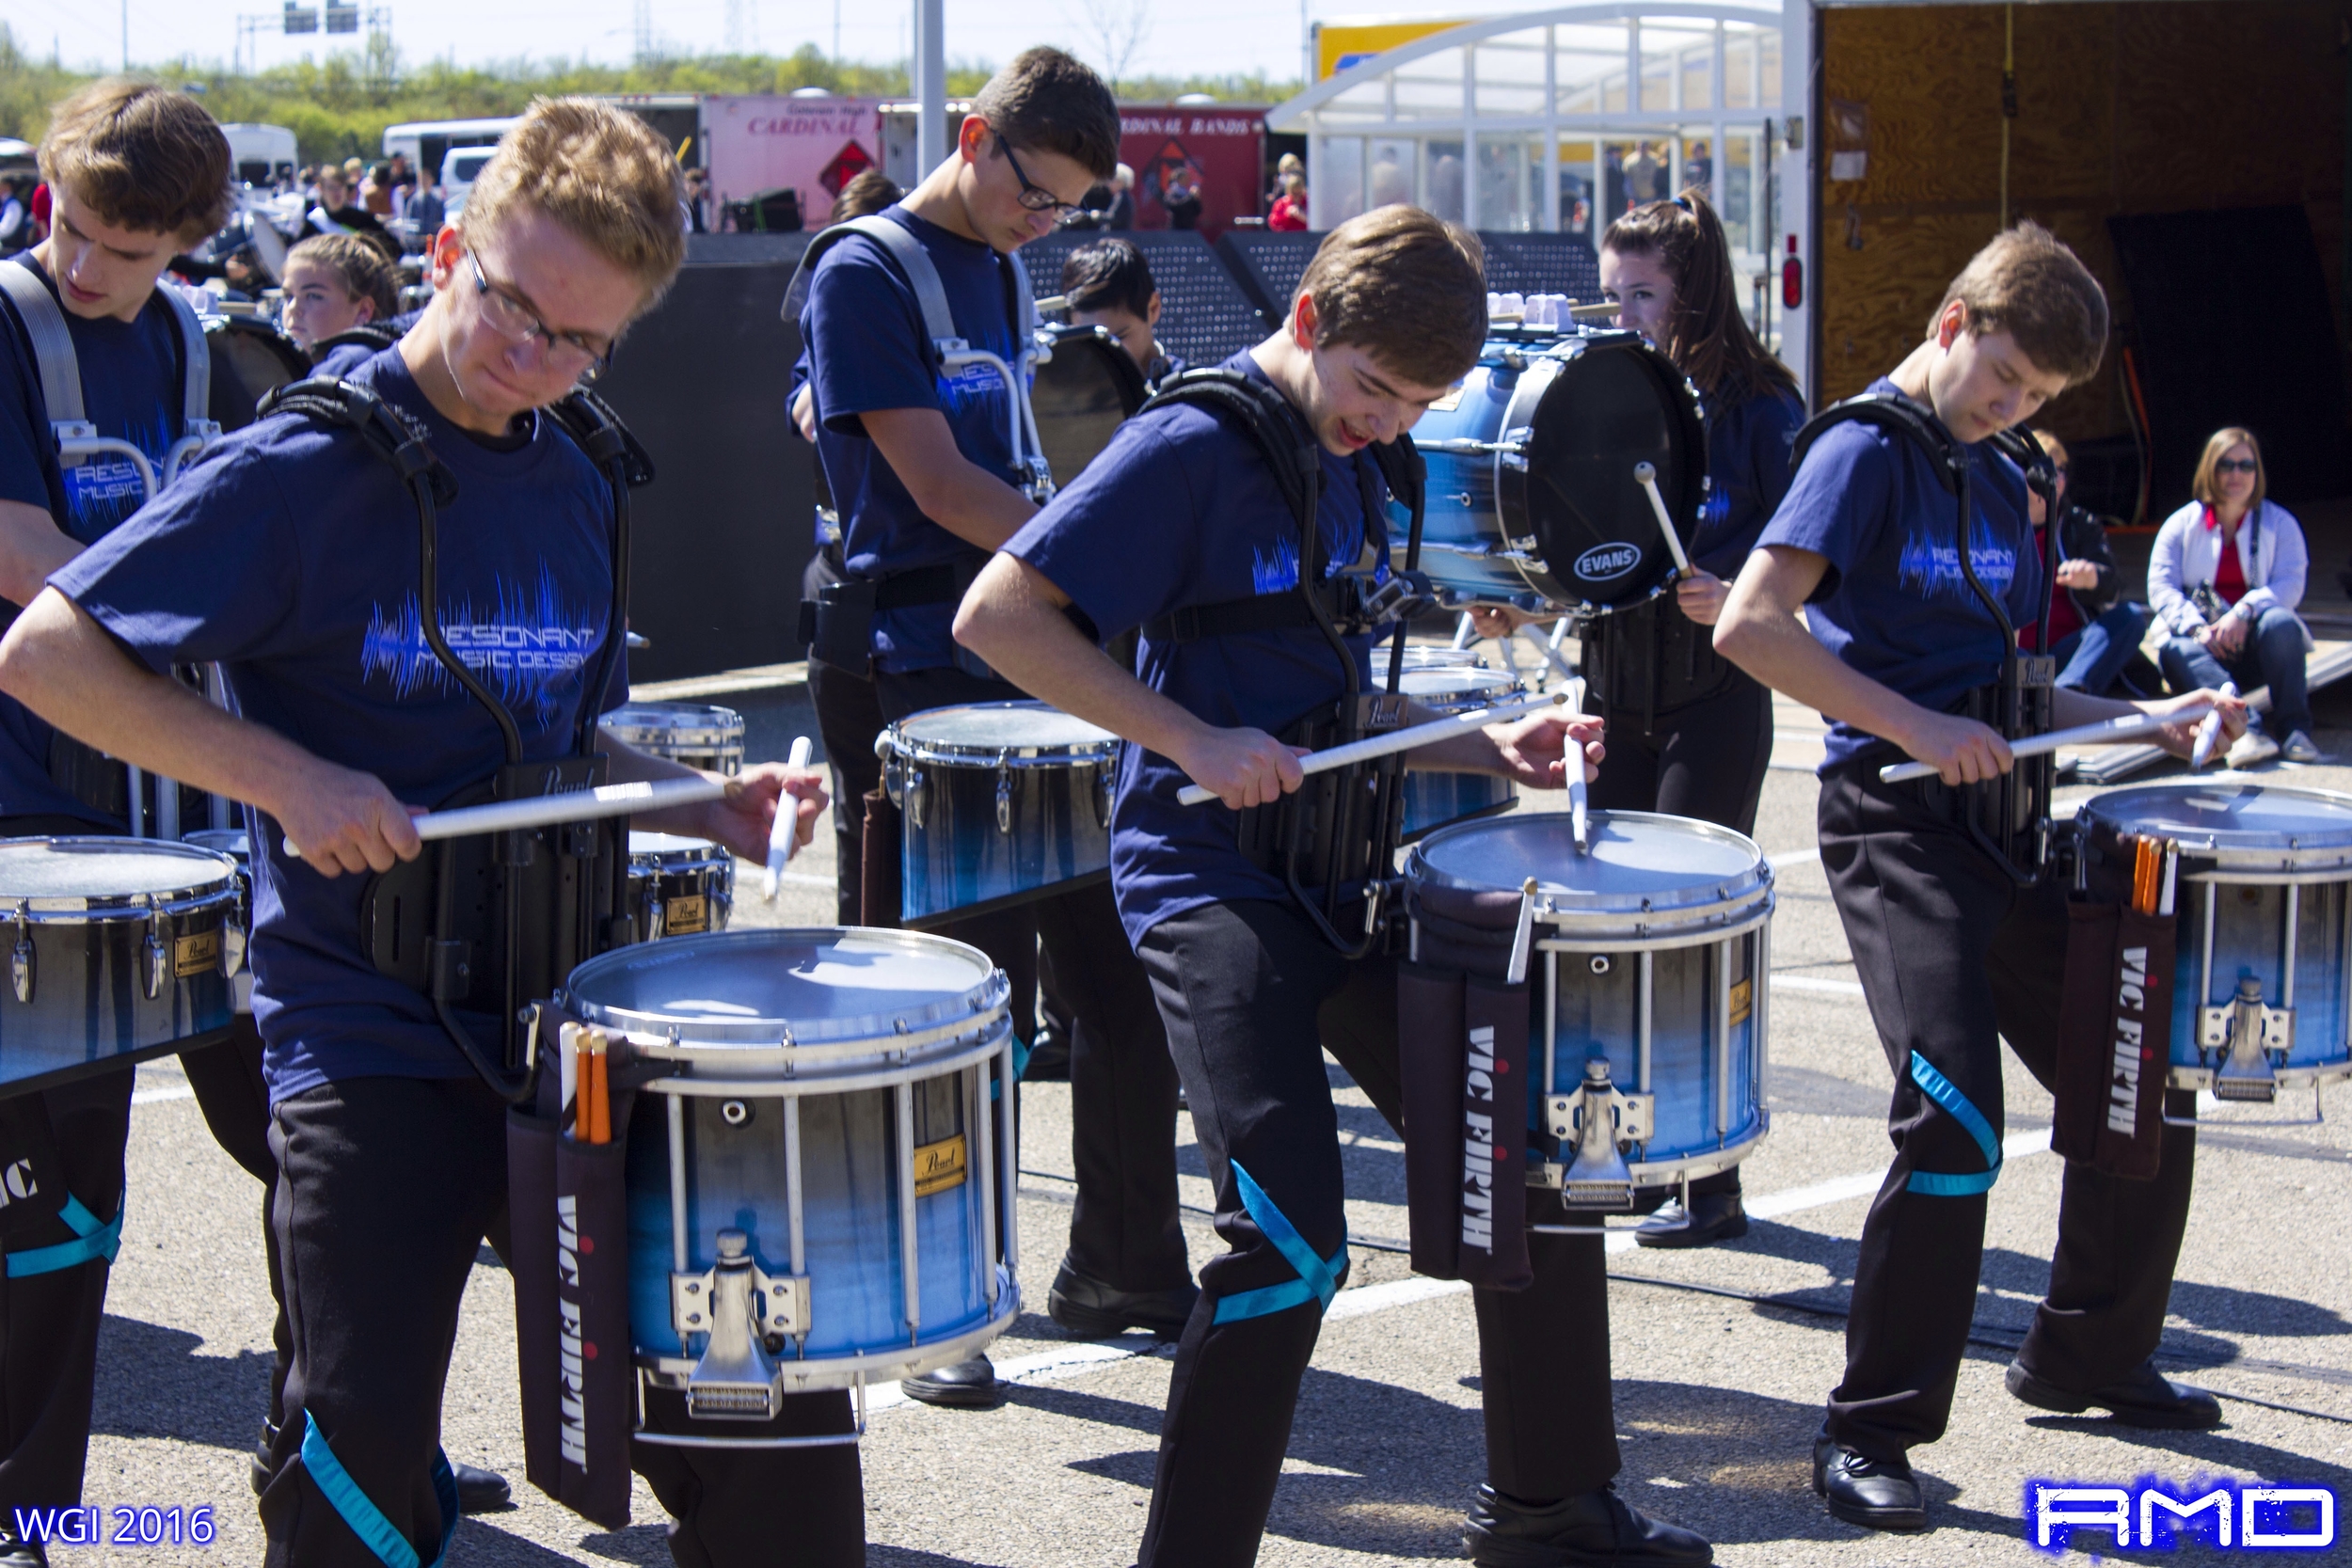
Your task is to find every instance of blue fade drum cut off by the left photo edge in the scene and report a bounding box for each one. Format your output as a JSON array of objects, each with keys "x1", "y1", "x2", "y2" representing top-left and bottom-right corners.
[{"x1": 0, "y1": 837, "x2": 245, "y2": 1093}]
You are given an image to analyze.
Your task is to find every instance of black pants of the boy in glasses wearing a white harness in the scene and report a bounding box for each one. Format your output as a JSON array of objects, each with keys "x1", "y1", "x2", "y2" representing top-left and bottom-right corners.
[{"x1": 875, "y1": 670, "x2": 1193, "y2": 1291}]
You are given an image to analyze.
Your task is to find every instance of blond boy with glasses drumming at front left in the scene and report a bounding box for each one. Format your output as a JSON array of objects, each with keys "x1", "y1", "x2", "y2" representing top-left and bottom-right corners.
[{"x1": 0, "y1": 99, "x2": 842, "y2": 1568}]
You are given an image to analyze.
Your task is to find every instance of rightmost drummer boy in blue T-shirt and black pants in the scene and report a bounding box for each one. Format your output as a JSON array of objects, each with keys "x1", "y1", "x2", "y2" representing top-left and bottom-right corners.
[{"x1": 1715, "y1": 223, "x2": 2247, "y2": 1530}]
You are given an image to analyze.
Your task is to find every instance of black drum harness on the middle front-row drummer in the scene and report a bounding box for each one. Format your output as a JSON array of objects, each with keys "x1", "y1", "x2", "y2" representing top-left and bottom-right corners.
[{"x1": 1136, "y1": 369, "x2": 1438, "y2": 959}]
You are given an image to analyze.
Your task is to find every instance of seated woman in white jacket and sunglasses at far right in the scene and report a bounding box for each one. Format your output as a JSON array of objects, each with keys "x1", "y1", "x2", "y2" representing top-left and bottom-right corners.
[{"x1": 2148, "y1": 425, "x2": 2319, "y2": 768}]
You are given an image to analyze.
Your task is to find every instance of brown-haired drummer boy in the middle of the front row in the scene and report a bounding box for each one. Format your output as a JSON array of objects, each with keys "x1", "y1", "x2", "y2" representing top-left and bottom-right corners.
[{"x1": 958, "y1": 207, "x2": 1712, "y2": 1568}]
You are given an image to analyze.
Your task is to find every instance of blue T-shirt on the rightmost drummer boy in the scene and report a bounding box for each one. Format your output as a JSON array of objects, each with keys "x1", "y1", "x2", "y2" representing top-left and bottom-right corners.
[{"x1": 1757, "y1": 376, "x2": 2042, "y2": 773}]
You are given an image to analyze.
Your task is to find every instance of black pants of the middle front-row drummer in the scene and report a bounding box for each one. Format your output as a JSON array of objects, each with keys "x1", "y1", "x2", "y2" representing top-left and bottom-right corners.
[{"x1": 1138, "y1": 900, "x2": 1618, "y2": 1568}]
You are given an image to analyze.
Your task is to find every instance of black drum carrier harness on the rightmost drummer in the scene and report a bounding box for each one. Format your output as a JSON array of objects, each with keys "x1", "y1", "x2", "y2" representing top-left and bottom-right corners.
[{"x1": 1788, "y1": 392, "x2": 2058, "y2": 886}]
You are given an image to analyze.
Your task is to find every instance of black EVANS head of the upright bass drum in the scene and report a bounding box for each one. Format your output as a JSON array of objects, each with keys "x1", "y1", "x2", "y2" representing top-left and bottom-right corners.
[{"x1": 1503, "y1": 334, "x2": 1708, "y2": 609}]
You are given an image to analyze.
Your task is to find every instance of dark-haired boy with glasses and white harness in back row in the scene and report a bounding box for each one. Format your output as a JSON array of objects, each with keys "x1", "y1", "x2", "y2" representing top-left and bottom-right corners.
[{"x1": 795, "y1": 49, "x2": 1198, "y2": 1406}]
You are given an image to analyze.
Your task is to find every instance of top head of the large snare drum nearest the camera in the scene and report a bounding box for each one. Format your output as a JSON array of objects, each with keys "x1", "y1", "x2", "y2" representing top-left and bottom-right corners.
[{"x1": 564, "y1": 928, "x2": 995, "y2": 1049}]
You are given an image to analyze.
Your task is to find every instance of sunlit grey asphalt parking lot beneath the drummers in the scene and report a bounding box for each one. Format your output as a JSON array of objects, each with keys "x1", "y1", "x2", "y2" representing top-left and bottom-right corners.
[{"x1": 73, "y1": 676, "x2": 2352, "y2": 1568}]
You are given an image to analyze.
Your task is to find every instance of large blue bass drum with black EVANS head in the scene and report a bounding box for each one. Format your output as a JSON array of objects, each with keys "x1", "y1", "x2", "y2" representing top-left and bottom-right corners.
[{"x1": 1391, "y1": 329, "x2": 1708, "y2": 613}]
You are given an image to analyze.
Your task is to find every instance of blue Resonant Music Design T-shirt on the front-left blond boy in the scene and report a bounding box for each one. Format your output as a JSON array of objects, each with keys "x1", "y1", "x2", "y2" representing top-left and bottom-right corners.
[{"x1": 50, "y1": 350, "x2": 628, "y2": 1101}]
